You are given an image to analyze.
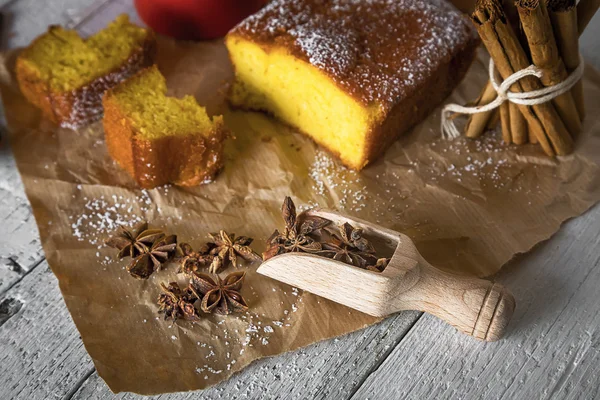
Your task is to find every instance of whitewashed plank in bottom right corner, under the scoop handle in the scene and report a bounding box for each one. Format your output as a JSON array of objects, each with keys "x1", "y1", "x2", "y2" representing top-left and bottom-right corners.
[{"x1": 352, "y1": 205, "x2": 600, "y2": 399}]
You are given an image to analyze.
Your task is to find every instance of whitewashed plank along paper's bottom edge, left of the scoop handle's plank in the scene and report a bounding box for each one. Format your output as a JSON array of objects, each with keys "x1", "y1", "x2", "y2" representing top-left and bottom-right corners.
[{"x1": 73, "y1": 312, "x2": 421, "y2": 400}]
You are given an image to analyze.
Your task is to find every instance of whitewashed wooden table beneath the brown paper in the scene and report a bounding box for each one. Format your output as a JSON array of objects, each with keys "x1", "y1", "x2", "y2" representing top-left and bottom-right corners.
[{"x1": 0, "y1": 0, "x2": 600, "y2": 400}]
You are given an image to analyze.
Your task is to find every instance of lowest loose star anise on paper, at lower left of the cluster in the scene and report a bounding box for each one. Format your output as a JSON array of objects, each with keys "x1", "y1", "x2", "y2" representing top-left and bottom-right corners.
[{"x1": 158, "y1": 282, "x2": 199, "y2": 321}]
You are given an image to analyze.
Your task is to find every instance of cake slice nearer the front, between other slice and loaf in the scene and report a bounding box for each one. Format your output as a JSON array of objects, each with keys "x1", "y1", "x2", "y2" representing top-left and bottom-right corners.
[{"x1": 102, "y1": 65, "x2": 227, "y2": 188}]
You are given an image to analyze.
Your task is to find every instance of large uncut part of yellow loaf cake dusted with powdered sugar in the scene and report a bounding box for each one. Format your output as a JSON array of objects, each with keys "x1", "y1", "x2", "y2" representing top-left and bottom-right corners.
[{"x1": 226, "y1": 0, "x2": 478, "y2": 169}]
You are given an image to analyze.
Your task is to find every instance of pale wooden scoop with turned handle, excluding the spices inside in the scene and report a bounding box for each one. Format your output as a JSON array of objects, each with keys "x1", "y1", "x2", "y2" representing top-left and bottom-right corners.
[{"x1": 258, "y1": 210, "x2": 515, "y2": 342}]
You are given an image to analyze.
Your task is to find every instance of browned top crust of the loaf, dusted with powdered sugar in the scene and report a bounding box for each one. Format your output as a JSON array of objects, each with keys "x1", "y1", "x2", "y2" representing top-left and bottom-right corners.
[{"x1": 229, "y1": 0, "x2": 477, "y2": 109}]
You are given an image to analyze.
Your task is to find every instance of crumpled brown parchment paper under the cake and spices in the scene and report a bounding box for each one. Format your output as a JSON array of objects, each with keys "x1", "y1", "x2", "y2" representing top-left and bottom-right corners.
[{"x1": 1, "y1": 36, "x2": 600, "y2": 394}]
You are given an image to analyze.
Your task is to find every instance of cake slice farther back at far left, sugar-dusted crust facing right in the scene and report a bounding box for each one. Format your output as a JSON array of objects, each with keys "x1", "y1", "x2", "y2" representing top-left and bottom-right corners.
[{"x1": 16, "y1": 15, "x2": 156, "y2": 128}]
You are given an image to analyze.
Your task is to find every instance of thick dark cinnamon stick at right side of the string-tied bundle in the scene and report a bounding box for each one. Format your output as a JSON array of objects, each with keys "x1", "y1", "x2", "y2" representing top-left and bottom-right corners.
[{"x1": 548, "y1": 0, "x2": 585, "y2": 122}]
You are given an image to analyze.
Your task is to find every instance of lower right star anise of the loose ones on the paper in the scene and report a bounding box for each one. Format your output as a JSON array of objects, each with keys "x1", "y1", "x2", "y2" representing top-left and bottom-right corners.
[{"x1": 191, "y1": 271, "x2": 248, "y2": 314}]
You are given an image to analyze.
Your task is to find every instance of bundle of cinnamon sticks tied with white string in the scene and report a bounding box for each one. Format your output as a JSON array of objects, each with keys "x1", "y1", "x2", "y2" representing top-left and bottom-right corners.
[{"x1": 465, "y1": 0, "x2": 600, "y2": 156}]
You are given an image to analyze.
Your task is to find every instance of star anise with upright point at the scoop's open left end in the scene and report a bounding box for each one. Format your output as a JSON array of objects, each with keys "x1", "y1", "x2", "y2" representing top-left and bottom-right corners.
[{"x1": 263, "y1": 196, "x2": 331, "y2": 260}]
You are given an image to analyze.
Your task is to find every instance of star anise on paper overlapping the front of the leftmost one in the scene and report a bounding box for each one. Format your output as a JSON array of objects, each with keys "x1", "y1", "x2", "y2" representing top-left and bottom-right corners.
[{"x1": 127, "y1": 235, "x2": 177, "y2": 279}]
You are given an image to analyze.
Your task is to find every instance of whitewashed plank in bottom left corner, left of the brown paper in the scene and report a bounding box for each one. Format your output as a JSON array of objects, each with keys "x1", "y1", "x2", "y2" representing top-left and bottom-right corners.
[{"x1": 0, "y1": 261, "x2": 93, "y2": 400}]
